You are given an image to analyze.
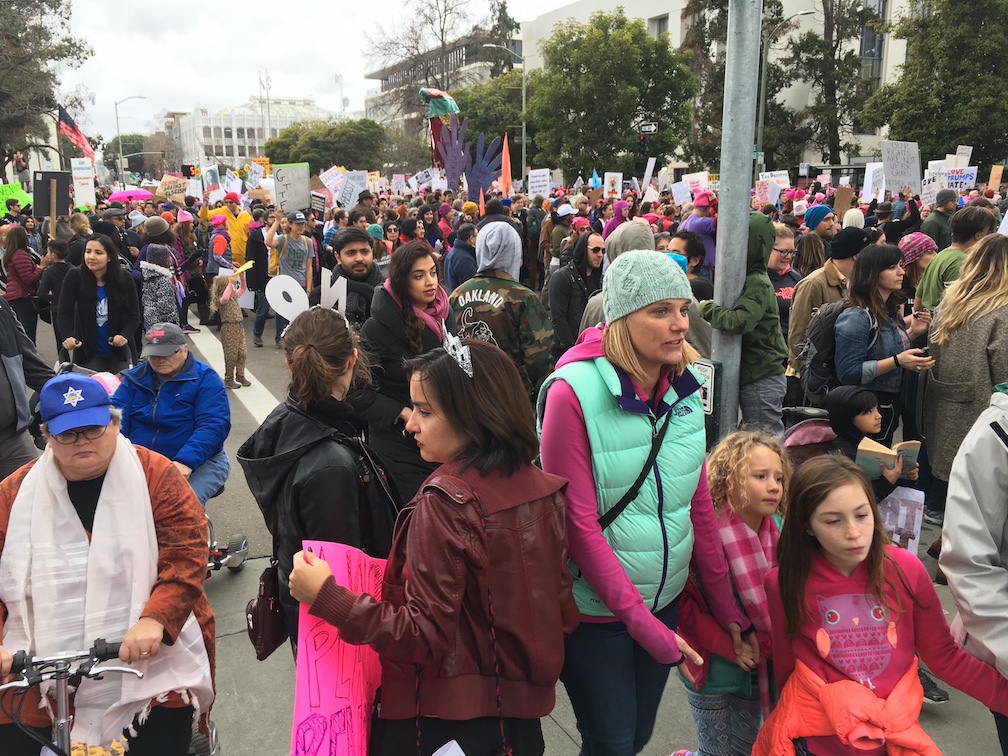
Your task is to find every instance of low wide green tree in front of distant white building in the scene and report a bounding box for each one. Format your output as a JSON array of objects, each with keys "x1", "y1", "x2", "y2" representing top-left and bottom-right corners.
[{"x1": 265, "y1": 119, "x2": 385, "y2": 173}]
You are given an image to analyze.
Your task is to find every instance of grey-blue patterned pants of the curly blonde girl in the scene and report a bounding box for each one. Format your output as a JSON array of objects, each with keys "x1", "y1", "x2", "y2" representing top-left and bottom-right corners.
[{"x1": 686, "y1": 687, "x2": 763, "y2": 756}]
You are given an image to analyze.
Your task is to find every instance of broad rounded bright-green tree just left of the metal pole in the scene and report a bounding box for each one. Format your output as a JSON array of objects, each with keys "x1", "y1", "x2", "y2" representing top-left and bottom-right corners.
[{"x1": 528, "y1": 8, "x2": 697, "y2": 176}]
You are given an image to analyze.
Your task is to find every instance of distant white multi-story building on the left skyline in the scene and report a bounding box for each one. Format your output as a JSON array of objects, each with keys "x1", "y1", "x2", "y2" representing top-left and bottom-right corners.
[{"x1": 171, "y1": 97, "x2": 348, "y2": 164}]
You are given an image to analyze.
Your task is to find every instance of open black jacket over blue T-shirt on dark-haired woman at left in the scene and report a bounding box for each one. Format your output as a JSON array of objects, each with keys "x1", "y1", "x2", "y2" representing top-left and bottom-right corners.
[{"x1": 56, "y1": 268, "x2": 140, "y2": 363}]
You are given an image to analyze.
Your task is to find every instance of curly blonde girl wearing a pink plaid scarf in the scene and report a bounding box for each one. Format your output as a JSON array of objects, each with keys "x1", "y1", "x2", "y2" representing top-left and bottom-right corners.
[{"x1": 673, "y1": 430, "x2": 791, "y2": 756}]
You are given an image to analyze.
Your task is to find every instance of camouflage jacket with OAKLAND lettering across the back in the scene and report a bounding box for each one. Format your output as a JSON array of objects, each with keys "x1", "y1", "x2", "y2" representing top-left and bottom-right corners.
[{"x1": 451, "y1": 270, "x2": 553, "y2": 406}]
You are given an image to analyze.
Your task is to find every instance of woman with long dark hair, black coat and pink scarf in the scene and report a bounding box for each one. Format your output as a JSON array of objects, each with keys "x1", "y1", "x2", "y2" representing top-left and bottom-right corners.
[{"x1": 348, "y1": 240, "x2": 456, "y2": 501}]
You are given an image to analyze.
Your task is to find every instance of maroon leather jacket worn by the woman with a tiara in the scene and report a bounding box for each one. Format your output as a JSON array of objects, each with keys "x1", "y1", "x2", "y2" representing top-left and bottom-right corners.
[{"x1": 310, "y1": 463, "x2": 581, "y2": 720}]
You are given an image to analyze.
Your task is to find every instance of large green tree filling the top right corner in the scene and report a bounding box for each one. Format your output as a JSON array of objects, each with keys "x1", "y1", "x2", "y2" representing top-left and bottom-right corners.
[{"x1": 861, "y1": 0, "x2": 1008, "y2": 165}]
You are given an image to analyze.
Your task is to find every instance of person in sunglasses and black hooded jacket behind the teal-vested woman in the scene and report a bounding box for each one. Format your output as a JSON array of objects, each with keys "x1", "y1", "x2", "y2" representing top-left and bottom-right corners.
[{"x1": 549, "y1": 231, "x2": 606, "y2": 361}]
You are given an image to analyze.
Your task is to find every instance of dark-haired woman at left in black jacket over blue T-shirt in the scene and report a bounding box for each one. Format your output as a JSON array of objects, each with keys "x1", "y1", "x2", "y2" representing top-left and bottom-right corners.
[{"x1": 56, "y1": 234, "x2": 140, "y2": 373}]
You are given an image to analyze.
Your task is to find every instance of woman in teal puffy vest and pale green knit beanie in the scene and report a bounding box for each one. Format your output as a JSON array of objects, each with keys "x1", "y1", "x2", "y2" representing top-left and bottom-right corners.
[{"x1": 538, "y1": 250, "x2": 758, "y2": 756}]
